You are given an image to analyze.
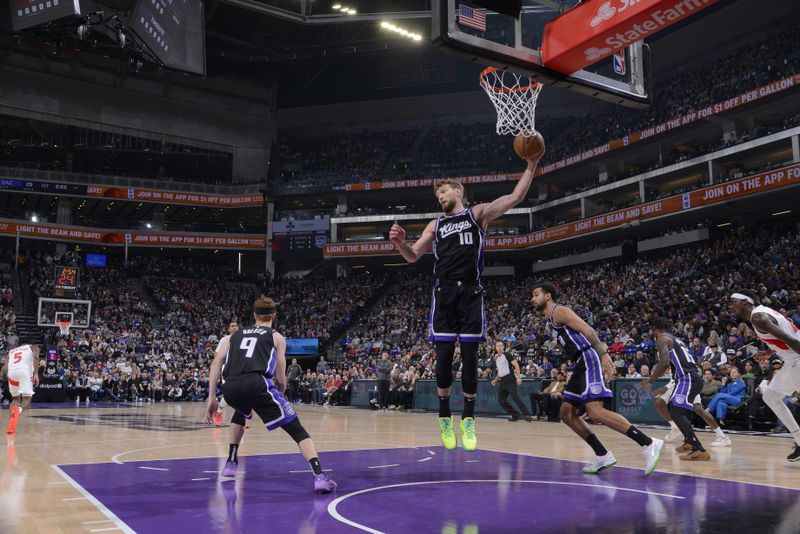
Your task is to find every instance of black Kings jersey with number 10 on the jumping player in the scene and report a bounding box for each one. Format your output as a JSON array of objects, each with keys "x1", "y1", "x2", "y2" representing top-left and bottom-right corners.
[{"x1": 433, "y1": 208, "x2": 484, "y2": 283}]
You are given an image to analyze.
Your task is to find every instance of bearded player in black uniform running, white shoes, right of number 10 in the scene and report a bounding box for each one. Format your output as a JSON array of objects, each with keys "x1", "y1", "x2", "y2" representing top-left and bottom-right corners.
[{"x1": 531, "y1": 282, "x2": 664, "y2": 475}]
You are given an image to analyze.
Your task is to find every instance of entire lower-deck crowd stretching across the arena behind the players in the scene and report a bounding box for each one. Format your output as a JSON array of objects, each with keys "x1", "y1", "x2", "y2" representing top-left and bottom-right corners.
[{"x1": 0, "y1": 222, "x2": 800, "y2": 436}]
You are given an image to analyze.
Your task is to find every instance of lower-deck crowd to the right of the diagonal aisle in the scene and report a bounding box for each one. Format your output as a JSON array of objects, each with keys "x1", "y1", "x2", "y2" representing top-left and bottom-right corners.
[{"x1": 341, "y1": 223, "x2": 800, "y2": 426}]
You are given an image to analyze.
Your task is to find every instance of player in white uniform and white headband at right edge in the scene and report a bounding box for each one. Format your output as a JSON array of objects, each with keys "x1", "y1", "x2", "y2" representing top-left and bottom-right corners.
[{"x1": 730, "y1": 290, "x2": 800, "y2": 462}]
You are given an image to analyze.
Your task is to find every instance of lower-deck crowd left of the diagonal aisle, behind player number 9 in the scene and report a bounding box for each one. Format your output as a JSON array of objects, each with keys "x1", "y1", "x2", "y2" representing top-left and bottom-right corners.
[{"x1": 3, "y1": 253, "x2": 385, "y2": 402}]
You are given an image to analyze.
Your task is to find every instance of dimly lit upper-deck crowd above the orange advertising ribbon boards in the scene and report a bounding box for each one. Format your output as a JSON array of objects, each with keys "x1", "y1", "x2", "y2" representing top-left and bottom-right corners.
[{"x1": 272, "y1": 26, "x2": 800, "y2": 195}]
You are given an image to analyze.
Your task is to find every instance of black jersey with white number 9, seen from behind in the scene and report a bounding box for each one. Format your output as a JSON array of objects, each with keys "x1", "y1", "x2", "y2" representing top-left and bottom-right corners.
[{"x1": 222, "y1": 325, "x2": 278, "y2": 378}]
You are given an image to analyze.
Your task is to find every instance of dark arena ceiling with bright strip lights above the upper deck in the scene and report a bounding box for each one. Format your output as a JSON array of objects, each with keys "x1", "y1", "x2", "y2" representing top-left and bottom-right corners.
[{"x1": 206, "y1": 0, "x2": 798, "y2": 108}]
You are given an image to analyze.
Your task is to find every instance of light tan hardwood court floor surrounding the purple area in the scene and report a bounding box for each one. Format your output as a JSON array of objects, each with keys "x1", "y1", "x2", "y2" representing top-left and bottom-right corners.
[{"x1": 0, "y1": 403, "x2": 800, "y2": 533}]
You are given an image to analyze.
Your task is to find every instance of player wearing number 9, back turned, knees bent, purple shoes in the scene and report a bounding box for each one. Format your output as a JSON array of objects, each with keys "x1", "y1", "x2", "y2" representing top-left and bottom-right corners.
[{"x1": 206, "y1": 297, "x2": 336, "y2": 494}]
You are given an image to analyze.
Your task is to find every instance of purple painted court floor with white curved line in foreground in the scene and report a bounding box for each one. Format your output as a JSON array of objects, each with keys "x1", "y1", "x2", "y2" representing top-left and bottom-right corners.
[{"x1": 60, "y1": 447, "x2": 800, "y2": 534}]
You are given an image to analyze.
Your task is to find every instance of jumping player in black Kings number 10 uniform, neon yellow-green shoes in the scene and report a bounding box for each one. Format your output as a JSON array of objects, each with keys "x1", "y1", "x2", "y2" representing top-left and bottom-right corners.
[{"x1": 389, "y1": 150, "x2": 544, "y2": 451}]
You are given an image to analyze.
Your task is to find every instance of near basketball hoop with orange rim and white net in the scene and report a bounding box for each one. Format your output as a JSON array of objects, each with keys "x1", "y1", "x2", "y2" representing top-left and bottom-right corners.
[{"x1": 480, "y1": 67, "x2": 542, "y2": 137}]
